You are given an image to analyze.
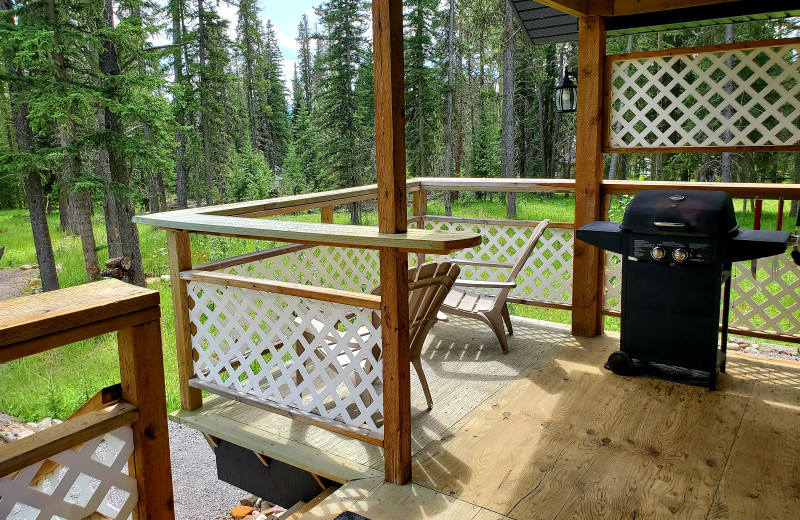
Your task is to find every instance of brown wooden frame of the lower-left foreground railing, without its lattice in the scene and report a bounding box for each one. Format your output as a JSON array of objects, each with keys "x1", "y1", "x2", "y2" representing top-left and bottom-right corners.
[{"x1": 0, "y1": 280, "x2": 174, "y2": 519}]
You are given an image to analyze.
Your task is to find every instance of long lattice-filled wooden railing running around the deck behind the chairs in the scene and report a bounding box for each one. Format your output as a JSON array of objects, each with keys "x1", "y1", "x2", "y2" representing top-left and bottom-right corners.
[{"x1": 136, "y1": 178, "x2": 800, "y2": 484}]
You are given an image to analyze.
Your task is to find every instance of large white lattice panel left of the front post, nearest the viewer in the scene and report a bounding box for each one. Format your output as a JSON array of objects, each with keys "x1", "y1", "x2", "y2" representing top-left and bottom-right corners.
[{"x1": 188, "y1": 282, "x2": 383, "y2": 433}]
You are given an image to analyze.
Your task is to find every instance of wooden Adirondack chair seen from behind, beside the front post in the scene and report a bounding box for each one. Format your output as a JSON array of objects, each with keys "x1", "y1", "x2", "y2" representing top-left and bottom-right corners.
[{"x1": 302, "y1": 262, "x2": 461, "y2": 410}]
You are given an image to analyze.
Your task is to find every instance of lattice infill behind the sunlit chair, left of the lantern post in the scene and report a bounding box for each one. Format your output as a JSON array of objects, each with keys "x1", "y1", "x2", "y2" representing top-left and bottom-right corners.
[{"x1": 425, "y1": 217, "x2": 573, "y2": 304}]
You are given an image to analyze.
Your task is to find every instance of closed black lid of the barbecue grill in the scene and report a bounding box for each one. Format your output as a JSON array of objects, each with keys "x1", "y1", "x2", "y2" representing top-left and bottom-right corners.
[{"x1": 620, "y1": 190, "x2": 739, "y2": 238}]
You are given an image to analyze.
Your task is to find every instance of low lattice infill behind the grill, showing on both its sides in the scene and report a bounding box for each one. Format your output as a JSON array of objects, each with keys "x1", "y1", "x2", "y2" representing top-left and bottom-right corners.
[{"x1": 604, "y1": 253, "x2": 800, "y2": 336}]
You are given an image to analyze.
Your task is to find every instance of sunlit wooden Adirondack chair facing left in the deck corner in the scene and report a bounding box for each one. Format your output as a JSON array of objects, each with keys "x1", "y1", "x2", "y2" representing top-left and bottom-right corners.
[{"x1": 442, "y1": 219, "x2": 550, "y2": 354}]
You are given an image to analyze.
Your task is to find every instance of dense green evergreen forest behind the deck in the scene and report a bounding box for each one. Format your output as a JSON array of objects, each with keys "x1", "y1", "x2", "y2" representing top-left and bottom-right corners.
[{"x1": 0, "y1": 0, "x2": 800, "y2": 290}]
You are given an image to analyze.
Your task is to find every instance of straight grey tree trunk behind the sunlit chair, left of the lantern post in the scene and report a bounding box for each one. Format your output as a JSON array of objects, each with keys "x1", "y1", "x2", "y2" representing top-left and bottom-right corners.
[{"x1": 500, "y1": 0, "x2": 517, "y2": 219}]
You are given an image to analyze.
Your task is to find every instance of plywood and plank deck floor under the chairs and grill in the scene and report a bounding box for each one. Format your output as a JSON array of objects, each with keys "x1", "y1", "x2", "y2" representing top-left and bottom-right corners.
[{"x1": 174, "y1": 318, "x2": 800, "y2": 520}]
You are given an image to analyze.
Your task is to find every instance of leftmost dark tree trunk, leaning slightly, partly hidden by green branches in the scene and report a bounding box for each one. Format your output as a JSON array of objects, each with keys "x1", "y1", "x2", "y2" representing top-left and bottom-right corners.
[{"x1": 0, "y1": 0, "x2": 58, "y2": 291}]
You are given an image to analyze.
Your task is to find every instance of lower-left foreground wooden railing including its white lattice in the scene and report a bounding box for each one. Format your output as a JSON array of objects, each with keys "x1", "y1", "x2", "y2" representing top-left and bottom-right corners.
[{"x1": 0, "y1": 280, "x2": 174, "y2": 520}]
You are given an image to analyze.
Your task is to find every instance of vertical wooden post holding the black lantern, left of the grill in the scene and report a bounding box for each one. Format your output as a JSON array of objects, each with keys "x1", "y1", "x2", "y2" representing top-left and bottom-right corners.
[{"x1": 572, "y1": 16, "x2": 606, "y2": 337}]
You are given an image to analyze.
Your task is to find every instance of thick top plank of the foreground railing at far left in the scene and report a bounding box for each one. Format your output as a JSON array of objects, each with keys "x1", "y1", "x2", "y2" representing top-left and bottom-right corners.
[{"x1": 0, "y1": 280, "x2": 159, "y2": 347}]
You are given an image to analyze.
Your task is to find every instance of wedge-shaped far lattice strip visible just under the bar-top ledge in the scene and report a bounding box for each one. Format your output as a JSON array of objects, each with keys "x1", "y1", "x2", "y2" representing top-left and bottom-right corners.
[{"x1": 223, "y1": 246, "x2": 380, "y2": 293}]
